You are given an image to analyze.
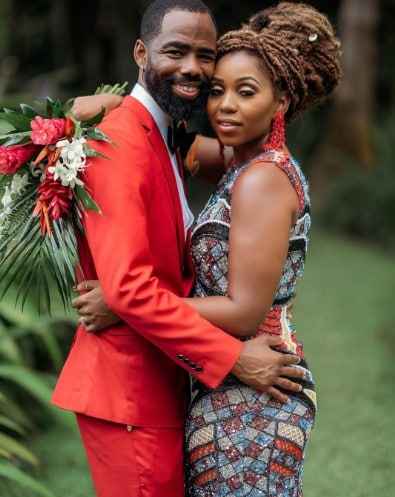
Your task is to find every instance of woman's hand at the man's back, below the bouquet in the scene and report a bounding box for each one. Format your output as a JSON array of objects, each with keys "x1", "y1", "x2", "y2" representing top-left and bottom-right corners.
[{"x1": 72, "y1": 280, "x2": 121, "y2": 332}]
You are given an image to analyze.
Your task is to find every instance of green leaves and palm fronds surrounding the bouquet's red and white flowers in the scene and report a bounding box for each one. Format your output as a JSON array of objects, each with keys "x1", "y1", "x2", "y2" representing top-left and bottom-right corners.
[{"x1": 0, "y1": 83, "x2": 123, "y2": 313}]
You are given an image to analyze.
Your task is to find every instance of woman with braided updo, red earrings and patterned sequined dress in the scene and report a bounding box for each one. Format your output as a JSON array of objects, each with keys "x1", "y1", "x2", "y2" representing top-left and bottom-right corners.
[{"x1": 72, "y1": 2, "x2": 341, "y2": 497}]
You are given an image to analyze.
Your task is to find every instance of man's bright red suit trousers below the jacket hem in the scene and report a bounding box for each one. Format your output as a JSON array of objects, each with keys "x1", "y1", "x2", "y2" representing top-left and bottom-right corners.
[{"x1": 77, "y1": 414, "x2": 184, "y2": 497}]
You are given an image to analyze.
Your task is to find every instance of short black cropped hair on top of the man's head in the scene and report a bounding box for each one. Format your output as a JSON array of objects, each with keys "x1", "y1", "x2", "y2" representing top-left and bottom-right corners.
[{"x1": 140, "y1": 0, "x2": 217, "y2": 43}]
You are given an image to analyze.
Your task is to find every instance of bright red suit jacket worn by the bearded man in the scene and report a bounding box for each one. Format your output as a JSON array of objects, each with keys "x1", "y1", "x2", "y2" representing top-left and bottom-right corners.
[{"x1": 53, "y1": 97, "x2": 242, "y2": 427}]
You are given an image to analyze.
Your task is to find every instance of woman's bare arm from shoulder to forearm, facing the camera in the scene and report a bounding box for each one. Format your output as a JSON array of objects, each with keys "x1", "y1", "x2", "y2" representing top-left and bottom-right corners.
[{"x1": 187, "y1": 163, "x2": 298, "y2": 336}]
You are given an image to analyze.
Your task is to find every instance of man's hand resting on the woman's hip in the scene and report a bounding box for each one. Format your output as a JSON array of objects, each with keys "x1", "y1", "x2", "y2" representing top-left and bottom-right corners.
[{"x1": 232, "y1": 335, "x2": 303, "y2": 402}]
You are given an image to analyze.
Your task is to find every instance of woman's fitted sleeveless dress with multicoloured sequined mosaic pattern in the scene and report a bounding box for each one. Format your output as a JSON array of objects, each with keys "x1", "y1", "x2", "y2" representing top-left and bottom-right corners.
[{"x1": 186, "y1": 151, "x2": 316, "y2": 497}]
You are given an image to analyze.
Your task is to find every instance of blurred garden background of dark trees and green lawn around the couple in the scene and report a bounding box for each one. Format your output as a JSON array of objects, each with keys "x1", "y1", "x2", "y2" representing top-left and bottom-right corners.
[{"x1": 0, "y1": 0, "x2": 395, "y2": 497}]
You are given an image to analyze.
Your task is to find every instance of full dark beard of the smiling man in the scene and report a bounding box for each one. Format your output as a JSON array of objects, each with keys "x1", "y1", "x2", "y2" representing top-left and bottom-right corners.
[{"x1": 145, "y1": 63, "x2": 210, "y2": 122}]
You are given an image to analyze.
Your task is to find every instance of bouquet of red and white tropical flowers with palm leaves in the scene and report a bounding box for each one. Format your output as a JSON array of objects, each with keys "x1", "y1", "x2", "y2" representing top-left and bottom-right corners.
[{"x1": 0, "y1": 83, "x2": 126, "y2": 312}]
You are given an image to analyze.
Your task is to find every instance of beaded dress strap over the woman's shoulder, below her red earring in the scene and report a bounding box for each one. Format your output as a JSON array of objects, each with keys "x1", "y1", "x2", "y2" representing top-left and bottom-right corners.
[{"x1": 252, "y1": 150, "x2": 308, "y2": 214}]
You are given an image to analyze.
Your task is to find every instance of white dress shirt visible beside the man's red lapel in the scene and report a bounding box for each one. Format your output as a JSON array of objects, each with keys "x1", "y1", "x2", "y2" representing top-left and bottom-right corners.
[{"x1": 131, "y1": 83, "x2": 194, "y2": 236}]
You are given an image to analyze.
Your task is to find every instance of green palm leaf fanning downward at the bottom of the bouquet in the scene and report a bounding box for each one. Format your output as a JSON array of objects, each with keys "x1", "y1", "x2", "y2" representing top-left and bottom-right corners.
[{"x1": 0, "y1": 180, "x2": 78, "y2": 312}]
